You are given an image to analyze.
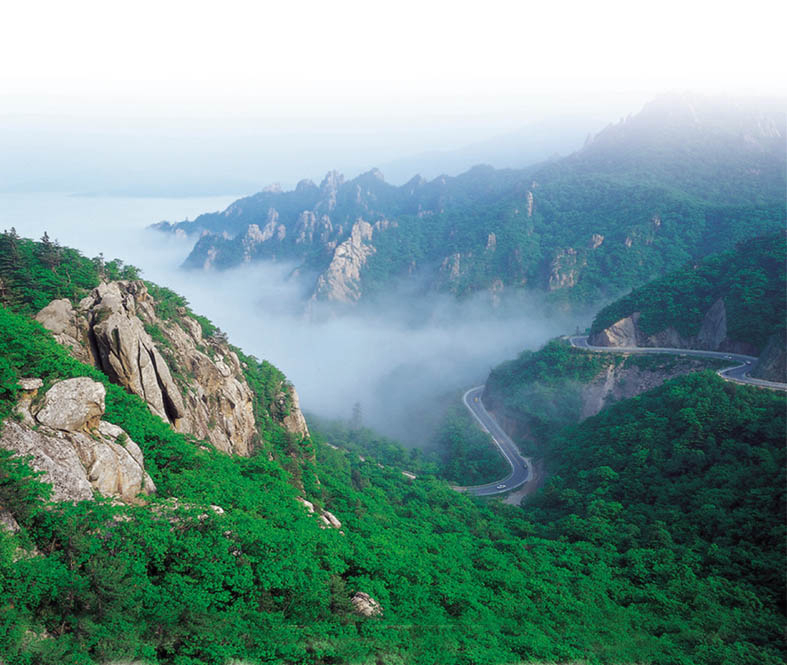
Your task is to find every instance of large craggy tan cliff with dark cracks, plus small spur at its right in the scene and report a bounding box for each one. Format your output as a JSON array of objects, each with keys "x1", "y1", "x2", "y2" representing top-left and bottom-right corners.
[{"x1": 36, "y1": 280, "x2": 308, "y2": 456}]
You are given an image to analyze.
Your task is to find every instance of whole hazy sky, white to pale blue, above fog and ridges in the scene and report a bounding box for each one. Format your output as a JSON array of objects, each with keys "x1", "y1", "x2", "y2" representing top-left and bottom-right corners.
[{"x1": 0, "y1": 0, "x2": 787, "y2": 195}]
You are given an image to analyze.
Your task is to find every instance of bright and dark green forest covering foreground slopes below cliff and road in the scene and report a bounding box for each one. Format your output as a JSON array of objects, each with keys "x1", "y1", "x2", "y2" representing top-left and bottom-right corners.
[{"x1": 0, "y1": 237, "x2": 787, "y2": 665}]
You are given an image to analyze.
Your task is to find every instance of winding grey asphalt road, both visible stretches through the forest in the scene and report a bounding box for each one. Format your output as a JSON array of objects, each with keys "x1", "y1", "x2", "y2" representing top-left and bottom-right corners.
[{"x1": 454, "y1": 335, "x2": 787, "y2": 496}]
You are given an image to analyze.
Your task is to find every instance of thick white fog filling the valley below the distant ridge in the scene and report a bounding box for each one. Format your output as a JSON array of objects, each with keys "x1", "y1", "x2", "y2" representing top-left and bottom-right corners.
[{"x1": 0, "y1": 194, "x2": 577, "y2": 445}]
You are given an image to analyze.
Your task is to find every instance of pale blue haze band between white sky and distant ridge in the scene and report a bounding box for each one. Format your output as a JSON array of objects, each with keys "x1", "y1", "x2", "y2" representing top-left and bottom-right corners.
[{"x1": 0, "y1": 101, "x2": 624, "y2": 197}]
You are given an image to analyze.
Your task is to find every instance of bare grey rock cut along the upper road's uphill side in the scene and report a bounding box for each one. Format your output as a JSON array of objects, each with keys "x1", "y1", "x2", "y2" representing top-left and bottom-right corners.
[{"x1": 588, "y1": 298, "x2": 756, "y2": 354}]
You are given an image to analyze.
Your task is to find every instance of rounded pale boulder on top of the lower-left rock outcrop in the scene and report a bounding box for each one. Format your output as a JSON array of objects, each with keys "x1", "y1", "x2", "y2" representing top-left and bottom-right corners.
[{"x1": 36, "y1": 377, "x2": 107, "y2": 432}]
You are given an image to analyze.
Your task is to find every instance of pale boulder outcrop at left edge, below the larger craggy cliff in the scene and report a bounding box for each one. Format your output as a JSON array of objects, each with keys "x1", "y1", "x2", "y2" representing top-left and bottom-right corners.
[{"x1": 0, "y1": 377, "x2": 156, "y2": 503}]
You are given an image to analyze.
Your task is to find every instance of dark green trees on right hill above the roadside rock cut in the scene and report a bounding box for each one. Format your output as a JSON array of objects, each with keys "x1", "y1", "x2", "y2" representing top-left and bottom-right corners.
[{"x1": 591, "y1": 231, "x2": 787, "y2": 350}]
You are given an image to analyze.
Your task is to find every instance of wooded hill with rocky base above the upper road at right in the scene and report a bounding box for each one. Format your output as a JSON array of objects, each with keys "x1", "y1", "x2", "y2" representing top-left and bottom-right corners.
[{"x1": 590, "y1": 231, "x2": 787, "y2": 382}]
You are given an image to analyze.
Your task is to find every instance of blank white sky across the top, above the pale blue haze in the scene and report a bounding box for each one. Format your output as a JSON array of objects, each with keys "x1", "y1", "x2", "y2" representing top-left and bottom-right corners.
[{"x1": 0, "y1": 0, "x2": 787, "y2": 118}]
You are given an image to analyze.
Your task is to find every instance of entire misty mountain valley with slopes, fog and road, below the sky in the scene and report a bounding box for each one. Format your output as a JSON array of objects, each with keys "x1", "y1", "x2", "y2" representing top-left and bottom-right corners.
[{"x1": 0, "y1": 95, "x2": 787, "y2": 665}]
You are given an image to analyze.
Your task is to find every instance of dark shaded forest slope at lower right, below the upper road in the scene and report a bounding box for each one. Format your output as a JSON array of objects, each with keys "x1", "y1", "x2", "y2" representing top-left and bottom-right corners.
[{"x1": 530, "y1": 373, "x2": 787, "y2": 664}]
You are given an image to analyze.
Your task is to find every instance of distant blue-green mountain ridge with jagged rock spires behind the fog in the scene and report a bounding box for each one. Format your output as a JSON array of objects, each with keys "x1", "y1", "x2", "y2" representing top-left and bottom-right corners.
[{"x1": 156, "y1": 95, "x2": 787, "y2": 303}]
